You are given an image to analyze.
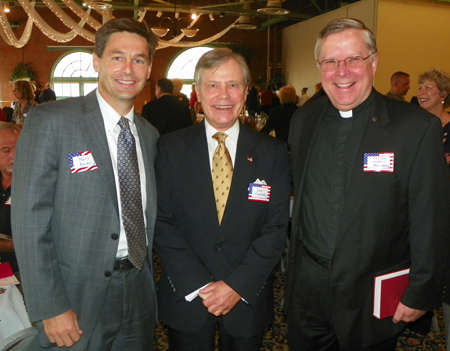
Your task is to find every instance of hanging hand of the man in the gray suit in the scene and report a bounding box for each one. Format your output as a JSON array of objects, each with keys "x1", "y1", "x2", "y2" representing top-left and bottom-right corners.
[{"x1": 42, "y1": 310, "x2": 83, "y2": 347}]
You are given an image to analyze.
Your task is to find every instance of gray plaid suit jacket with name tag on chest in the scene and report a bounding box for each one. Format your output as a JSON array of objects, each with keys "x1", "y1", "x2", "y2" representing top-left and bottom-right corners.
[{"x1": 12, "y1": 92, "x2": 158, "y2": 350}]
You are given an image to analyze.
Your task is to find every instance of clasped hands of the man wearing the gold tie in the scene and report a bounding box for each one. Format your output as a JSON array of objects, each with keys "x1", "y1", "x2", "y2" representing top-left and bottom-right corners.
[{"x1": 199, "y1": 281, "x2": 241, "y2": 317}]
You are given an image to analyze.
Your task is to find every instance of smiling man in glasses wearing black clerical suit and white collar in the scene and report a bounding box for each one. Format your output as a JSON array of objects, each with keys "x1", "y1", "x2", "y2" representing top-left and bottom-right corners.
[{"x1": 285, "y1": 19, "x2": 450, "y2": 351}]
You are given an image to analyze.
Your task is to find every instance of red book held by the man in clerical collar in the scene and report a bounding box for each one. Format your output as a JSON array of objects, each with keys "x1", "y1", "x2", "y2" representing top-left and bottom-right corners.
[{"x1": 373, "y1": 268, "x2": 409, "y2": 319}]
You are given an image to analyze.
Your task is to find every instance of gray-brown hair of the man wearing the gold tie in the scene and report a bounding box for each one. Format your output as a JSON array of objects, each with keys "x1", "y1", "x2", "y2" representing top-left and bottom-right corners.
[{"x1": 194, "y1": 48, "x2": 252, "y2": 87}]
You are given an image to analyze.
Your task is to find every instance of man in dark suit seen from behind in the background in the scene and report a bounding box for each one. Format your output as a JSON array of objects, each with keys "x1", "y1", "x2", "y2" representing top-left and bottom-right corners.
[{"x1": 142, "y1": 78, "x2": 192, "y2": 135}]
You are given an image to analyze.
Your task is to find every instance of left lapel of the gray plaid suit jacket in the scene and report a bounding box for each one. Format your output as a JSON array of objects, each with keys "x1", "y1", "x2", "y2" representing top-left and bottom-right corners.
[{"x1": 80, "y1": 91, "x2": 118, "y2": 211}]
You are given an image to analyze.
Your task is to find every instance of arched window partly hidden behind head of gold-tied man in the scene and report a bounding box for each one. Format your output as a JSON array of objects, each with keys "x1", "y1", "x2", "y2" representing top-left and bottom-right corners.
[{"x1": 167, "y1": 46, "x2": 212, "y2": 96}]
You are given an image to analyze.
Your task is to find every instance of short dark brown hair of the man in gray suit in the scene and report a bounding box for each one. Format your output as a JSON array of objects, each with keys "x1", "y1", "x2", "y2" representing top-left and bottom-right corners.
[{"x1": 94, "y1": 18, "x2": 158, "y2": 63}]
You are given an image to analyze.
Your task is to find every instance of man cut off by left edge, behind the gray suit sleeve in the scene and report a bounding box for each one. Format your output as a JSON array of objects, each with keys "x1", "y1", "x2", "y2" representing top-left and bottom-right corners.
[{"x1": 0, "y1": 122, "x2": 21, "y2": 274}]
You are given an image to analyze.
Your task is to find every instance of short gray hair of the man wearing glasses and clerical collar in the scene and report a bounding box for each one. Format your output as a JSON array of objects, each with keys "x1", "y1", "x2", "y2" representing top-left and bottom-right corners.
[{"x1": 314, "y1": 18, "x2": 378, "y2": 62}]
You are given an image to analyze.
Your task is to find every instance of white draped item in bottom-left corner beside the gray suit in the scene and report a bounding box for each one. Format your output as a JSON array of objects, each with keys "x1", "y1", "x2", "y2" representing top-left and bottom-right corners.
[{"x1": 0, "y1": 285, "x2": 31, "y2": 342}]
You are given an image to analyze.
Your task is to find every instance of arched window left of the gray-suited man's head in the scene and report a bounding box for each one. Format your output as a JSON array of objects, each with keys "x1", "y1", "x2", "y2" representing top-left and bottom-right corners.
[{"x1": 50, "y1": 51, "x2": 98, "y2": 99}]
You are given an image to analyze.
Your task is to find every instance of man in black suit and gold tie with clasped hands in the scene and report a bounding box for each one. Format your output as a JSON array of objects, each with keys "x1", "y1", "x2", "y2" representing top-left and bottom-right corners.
[{"x1": 155, "y1": 48, "x2": 290, "y2": 351}]
